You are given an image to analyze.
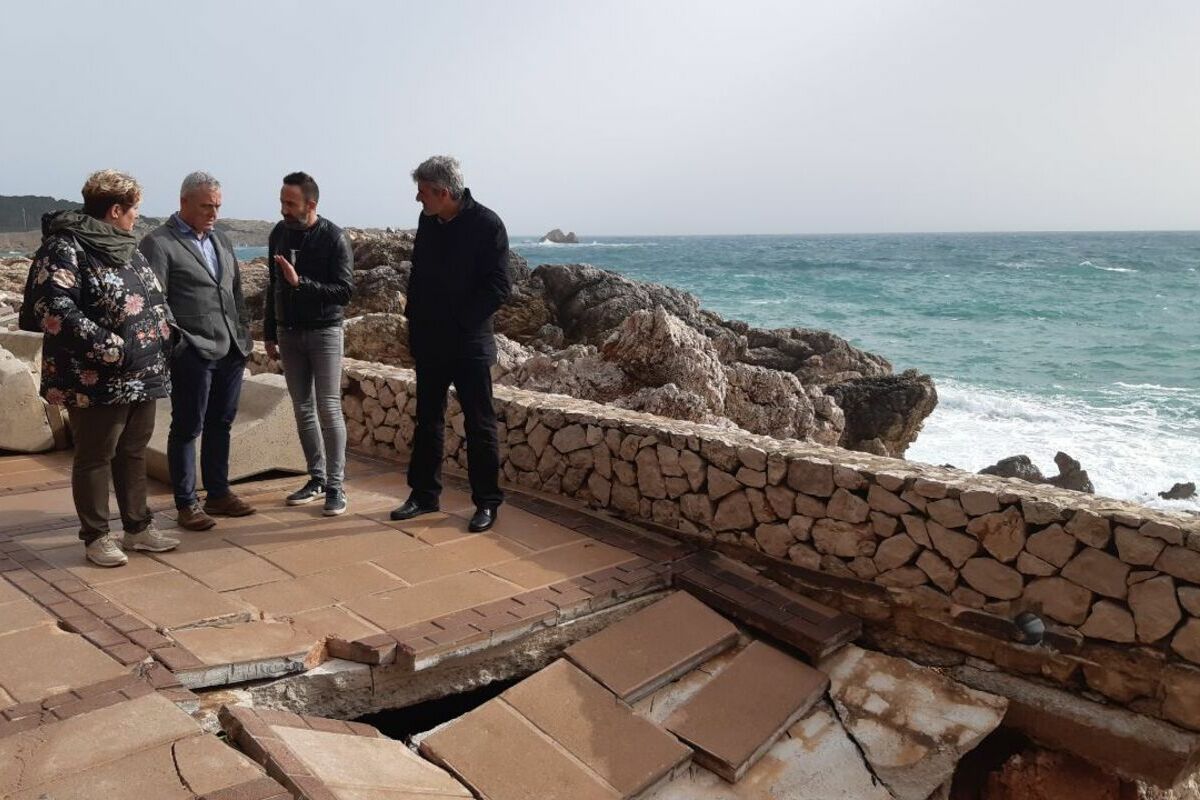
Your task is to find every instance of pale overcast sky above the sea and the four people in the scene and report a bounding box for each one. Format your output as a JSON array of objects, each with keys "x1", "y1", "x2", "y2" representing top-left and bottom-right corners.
[{"x1": 0, "y1": 0, "x2": 1200, "y2": 235}]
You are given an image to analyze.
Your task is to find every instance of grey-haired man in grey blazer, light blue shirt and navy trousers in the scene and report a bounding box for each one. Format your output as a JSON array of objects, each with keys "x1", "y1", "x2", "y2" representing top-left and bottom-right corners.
[{"x1": 139, "y1": 173, "x2": 254, "y2": 530}]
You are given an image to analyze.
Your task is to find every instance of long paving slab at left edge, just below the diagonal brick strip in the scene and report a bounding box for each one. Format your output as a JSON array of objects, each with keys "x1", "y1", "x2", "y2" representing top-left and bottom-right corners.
[{"x1": 0, "y1": 693, "x2": 200, "y2": 796}]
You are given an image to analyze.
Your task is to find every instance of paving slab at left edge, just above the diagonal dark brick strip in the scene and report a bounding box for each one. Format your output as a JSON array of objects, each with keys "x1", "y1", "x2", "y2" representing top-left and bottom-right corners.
[{"x1": 0, "y1": 625, "x2": 128, "y2": 700}]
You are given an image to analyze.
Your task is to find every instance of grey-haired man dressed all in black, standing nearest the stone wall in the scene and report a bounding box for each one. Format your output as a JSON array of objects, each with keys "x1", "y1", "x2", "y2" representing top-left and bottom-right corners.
[{"x1": 391, "y1": 156, "x2": 509, "y2": 533}]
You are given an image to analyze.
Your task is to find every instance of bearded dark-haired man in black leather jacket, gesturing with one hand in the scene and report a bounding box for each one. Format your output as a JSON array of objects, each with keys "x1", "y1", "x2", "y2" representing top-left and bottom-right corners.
[{"x1": 263, "y1": 173, "x2": 354, "y2": 517}]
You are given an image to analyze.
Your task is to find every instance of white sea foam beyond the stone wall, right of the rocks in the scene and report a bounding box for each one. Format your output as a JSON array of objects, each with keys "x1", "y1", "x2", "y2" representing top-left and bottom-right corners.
[{"x1": 906, "y1": 380, "x2": 1200, "y2": 511}]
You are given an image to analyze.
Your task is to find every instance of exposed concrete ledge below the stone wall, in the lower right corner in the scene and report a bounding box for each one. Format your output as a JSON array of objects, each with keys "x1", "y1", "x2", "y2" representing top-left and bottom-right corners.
[{"x1": 946, "y1": 666, "x2": 1200, "y2": 788}]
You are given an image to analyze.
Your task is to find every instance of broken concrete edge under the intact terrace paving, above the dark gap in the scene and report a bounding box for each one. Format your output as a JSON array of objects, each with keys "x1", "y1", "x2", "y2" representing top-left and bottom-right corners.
[{"x1": 244, "y1": 591, "x2": 667, "y2": 720}]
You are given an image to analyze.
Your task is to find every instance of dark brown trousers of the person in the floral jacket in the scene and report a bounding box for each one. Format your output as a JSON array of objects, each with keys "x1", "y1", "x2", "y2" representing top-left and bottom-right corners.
[{"x1": 71, "y1": 401, "x2": 155, "y2": 545}]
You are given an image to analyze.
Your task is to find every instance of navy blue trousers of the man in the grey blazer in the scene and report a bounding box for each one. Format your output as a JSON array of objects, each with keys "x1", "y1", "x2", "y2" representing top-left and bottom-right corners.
[{"x1": 167, "y1": 347, "x2": 246, "y2": 509}]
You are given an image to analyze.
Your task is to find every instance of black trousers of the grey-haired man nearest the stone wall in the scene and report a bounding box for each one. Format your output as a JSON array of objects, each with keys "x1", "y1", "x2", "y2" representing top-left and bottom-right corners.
[{"x1": 408, "y1": 359, "x2": 504, "y2": 507}]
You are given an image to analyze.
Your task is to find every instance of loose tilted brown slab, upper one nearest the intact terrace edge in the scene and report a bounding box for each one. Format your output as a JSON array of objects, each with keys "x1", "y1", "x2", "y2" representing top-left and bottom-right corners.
[{"x1": 566, "y1": 591, "x2": 738, "y2": 703}]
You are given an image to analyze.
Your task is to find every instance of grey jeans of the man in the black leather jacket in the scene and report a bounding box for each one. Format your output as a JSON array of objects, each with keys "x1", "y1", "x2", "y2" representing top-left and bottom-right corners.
[{"x1": 278, "y1": 325, "x2": 346, "y2": 488}]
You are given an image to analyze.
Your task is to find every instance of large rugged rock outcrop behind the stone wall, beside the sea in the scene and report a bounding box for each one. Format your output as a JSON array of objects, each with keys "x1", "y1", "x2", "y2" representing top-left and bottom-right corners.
[{"x1": 244, "y1": 229, "x2": 937, "y2": 456}]
